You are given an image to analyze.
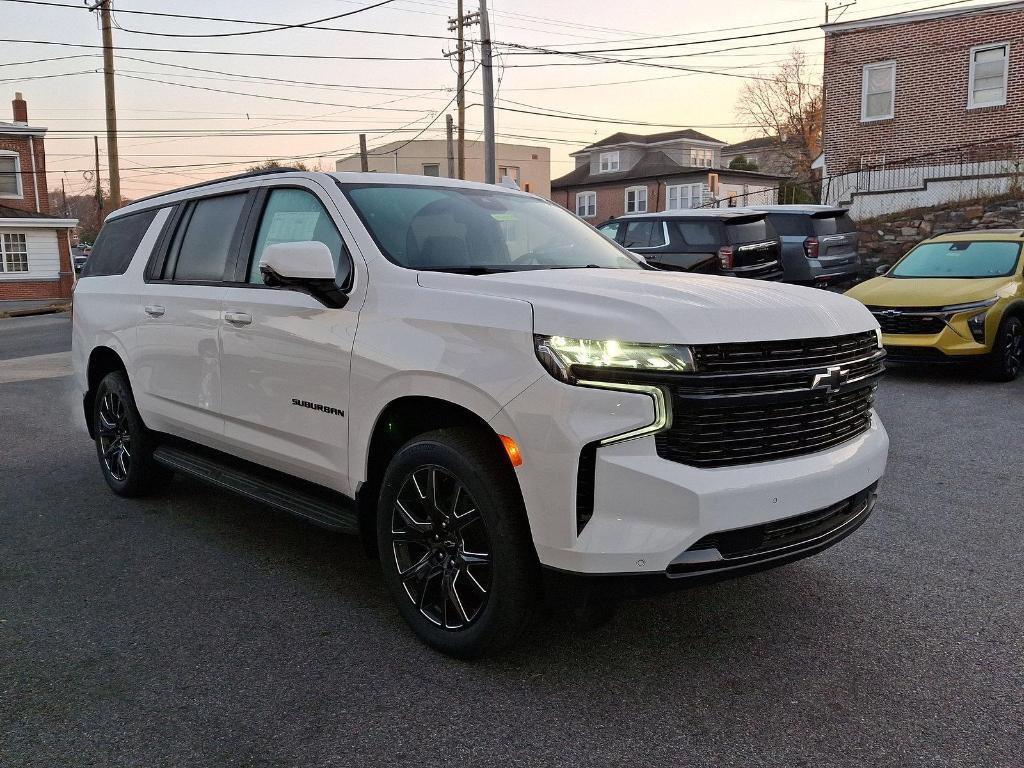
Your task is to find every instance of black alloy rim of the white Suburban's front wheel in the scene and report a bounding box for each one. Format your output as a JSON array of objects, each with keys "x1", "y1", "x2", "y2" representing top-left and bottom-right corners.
[{"x1": 391, "y1": 465, "x2": 492, "y2": 630}]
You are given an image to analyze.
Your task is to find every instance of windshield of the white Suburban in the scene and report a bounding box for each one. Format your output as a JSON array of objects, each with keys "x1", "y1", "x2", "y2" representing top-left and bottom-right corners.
[{"x1": 341, "y1": 184, "x2": 643, "y2": 274}]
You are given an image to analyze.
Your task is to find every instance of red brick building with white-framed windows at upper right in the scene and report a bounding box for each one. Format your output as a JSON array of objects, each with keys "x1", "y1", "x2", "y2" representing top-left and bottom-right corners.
[{"x1": 818, "y1": 2, "x2": 1024, "y2": 217}]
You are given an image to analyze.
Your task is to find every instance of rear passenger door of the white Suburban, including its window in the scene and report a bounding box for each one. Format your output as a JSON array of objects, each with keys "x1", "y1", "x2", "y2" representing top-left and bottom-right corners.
[{"x1": 134, "y1": 190, "x2": 254, "y2": 447}]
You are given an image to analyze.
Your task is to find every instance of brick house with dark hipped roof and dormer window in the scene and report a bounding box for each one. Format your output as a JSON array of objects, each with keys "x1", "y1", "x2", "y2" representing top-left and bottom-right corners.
[{"x1": 551, "y1": 128, "x2": 783, "y2": 223}]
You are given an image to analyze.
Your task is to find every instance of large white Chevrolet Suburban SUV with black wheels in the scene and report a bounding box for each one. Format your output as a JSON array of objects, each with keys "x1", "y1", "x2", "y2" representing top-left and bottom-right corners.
[{"x1": 73, "y1": 171, "x2": 889, "y2": 656}]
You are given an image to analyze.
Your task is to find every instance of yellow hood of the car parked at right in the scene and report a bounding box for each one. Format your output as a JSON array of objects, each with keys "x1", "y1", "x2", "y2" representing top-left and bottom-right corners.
[{"x1": 846, "y1": 276, "x2": 1014, "y2": 307}]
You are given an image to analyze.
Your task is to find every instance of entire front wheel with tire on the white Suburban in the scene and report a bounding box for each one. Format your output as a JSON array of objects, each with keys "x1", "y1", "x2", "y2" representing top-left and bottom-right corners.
[{"x1": 377, "y1": 428, "x2": 540, "y2": 658}]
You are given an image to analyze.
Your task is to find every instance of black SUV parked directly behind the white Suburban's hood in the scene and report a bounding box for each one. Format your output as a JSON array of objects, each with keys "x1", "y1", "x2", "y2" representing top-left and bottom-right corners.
[{"x1": 598, "y1": 208, "x2": 782, "y2": 281}]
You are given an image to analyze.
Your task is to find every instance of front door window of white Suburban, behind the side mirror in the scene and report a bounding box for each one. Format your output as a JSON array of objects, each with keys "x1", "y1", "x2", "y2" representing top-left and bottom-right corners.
[{"x1": 249, "y1": 187, "x2": 348, "y2": 285}]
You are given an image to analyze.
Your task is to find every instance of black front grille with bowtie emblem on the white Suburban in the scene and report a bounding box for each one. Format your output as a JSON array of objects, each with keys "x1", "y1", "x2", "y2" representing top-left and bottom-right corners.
[{"x1": 655, "y1": 331, "x2": 885, "y2": 467}]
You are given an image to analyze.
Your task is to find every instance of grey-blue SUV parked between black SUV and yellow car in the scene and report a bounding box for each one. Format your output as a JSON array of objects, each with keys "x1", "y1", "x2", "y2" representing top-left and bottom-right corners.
[{"x1": 757, "y1": 205, "x2": 861, "y2": 286}]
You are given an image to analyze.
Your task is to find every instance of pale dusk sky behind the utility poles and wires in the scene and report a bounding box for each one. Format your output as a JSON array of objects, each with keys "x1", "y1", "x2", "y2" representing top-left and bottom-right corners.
[{"x1": 0, "y1": 0, "x2": 1007, "y2": 198}]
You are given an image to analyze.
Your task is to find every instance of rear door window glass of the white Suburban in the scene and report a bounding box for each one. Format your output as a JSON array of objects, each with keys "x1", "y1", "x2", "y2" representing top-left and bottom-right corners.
[{"x1": 164, "y1": 193, "x2": 247, "y2": 283}]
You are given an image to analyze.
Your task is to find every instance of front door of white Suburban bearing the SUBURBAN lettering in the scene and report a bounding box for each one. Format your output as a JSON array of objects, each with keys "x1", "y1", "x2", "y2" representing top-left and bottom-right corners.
[{"x1": 220, "y1": 181, "x2": 362, "y2": 493}]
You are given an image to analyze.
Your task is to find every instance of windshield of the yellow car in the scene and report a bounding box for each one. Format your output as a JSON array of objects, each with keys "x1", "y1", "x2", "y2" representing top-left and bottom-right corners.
[{"x1": 886, "y1": 240, "x2": 1021, "y2": 278}]
